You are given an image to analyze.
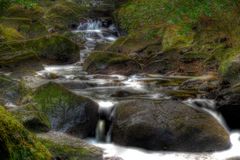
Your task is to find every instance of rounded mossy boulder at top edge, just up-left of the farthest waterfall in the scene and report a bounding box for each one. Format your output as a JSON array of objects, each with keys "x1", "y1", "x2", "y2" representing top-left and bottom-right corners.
[{"x1": 45, "y1": 1, "x2": 88, "y2": 31}]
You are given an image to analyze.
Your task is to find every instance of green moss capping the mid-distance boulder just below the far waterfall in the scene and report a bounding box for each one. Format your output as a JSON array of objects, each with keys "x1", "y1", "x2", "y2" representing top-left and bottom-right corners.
[{"x1": 84, "y1": 52, "x2": 133, "y2": 70}]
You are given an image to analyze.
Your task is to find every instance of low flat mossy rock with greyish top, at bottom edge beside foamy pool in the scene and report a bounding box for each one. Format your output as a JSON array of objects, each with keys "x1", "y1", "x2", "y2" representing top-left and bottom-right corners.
[{"x1": 38, "y1": 132, "x2": 102, "y2": 160}]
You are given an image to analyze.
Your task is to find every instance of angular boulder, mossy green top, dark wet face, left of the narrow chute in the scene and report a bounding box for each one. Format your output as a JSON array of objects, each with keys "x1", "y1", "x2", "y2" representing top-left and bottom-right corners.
[{"x1": 33, "y1": 82, "x2": 98, "y2": 138}]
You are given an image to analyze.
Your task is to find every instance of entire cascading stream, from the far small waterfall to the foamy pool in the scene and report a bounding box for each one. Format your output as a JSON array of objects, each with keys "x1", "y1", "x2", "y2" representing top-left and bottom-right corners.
[{"x1": 34, "y1": 5, "x2": 240, "y2": 160}]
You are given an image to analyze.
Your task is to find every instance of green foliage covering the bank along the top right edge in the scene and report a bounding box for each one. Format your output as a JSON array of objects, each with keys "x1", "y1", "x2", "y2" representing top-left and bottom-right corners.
[{"x1": 116, "y1": 0, "x2": 238, "y2": 31}]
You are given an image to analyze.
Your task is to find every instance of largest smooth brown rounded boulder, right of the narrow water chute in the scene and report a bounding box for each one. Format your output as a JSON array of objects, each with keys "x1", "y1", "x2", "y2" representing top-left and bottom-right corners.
[{"x1": 112, "y1": 100, "x2": 230, "y2": 152}]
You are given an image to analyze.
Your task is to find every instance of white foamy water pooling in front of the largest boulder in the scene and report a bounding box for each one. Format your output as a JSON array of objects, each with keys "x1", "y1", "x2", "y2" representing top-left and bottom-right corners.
[{"x1": 90, "y1": 132, "x2": 240, "y2": 160}]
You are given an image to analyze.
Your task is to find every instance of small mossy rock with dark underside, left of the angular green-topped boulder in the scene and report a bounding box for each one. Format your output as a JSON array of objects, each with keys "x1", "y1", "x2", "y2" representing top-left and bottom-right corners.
[{"x1": 11, "y1": 104, "x2": 51, "y2": 132}]
